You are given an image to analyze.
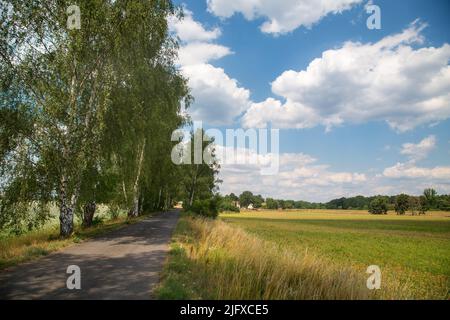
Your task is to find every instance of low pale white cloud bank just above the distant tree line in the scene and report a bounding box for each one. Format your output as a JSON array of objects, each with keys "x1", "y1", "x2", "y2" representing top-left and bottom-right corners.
[{"x1": 217, "y1": 146, "x2": 450, "y2": 202}]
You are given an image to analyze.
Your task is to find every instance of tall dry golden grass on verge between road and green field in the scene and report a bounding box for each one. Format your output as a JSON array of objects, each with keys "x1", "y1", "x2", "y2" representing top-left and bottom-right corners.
[{"x1": 159, "y1": 217, "x2": 384, "y2": 300}]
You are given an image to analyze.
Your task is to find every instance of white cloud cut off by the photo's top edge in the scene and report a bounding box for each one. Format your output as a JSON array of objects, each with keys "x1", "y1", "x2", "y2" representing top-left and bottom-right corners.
[{"x1": 208, "y1": 0, "x2": 362, "y2": 34}]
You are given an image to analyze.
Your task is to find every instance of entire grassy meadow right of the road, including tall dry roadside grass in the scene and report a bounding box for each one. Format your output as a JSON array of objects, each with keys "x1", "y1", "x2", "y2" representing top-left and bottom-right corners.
[{"x1": 159, "y1": 210, "x2": 450, "y2": 299}]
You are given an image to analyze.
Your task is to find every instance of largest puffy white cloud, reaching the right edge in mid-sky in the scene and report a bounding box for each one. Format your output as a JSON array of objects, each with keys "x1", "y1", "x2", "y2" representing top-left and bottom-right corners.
[{"x1": 243, "y1": 21, "x2": 450, "y2": 132}]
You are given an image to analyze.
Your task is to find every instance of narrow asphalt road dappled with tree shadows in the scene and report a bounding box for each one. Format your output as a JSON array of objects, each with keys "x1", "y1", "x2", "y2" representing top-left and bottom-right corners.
[{"x1": 0, "y1": 211, "x2": 179, "y2": 300}]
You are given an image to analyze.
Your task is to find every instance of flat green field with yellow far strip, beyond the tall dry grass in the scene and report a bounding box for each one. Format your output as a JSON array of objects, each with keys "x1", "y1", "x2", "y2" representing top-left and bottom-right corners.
[{"x1": 221, "y1": 211, "x2": 450, "y2": 298}]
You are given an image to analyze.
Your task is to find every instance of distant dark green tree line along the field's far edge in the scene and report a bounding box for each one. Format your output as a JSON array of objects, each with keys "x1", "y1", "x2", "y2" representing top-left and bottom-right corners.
[{"x1": 222, "y1": 189, "x2": 450, "y2": 214}]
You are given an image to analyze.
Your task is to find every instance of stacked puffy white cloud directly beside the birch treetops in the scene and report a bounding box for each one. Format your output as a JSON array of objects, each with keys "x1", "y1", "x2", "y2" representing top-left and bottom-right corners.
[{"x1": 168, "y1": 9, "x2": 250, "y2": 125}]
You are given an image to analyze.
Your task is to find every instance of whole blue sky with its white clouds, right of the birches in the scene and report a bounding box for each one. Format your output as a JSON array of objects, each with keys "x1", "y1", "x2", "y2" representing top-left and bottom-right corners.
[{"x1": 172, "y1": 0, "x2": 450, "y2": 201}]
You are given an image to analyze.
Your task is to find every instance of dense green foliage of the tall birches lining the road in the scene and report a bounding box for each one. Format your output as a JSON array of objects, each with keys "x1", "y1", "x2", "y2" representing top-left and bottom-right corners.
[{"x1": 0, "y1": 0, "x2": 218, "y2": 236}]
